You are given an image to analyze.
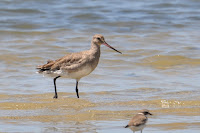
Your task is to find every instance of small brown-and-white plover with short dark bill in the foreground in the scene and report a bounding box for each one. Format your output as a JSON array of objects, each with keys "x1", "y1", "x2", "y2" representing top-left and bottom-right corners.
[{"x1": 125, "y1": 109, "x2": 152, "y2": 133}]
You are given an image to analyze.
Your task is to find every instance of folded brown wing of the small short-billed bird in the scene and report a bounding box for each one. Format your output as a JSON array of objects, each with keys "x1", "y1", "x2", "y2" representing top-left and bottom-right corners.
[{"x1": 128, "y1": 115, "x2": 147, "y2": 126}]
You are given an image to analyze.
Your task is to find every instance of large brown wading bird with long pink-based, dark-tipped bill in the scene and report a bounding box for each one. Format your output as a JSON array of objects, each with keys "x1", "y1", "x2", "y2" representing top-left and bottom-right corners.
[{"x1": 37, "y1": 34, "x2": 122, "y2": 98}]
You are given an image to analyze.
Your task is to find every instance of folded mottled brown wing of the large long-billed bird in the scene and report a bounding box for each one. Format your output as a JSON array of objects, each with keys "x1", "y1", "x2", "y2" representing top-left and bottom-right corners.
[{"x1": 37, "y1": 53, "x2": 87, "y2": 71}]
